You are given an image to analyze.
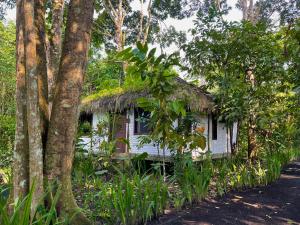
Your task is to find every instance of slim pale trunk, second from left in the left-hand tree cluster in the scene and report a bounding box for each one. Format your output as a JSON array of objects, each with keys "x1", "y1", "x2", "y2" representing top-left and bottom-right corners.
[{"x1": 24, "y1": 0, "x2": 43, "y2": 213}]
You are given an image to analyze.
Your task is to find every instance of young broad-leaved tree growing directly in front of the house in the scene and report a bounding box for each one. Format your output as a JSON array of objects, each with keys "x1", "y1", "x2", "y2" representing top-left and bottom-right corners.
[{"x1": 118, "y1": 43, "x2": 205, "y2": 156}]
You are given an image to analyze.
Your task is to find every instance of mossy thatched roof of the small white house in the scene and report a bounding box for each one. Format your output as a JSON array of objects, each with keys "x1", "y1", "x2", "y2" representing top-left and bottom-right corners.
[{"x1": 81, "y1": 77, "x2": 214, "y2": 112}]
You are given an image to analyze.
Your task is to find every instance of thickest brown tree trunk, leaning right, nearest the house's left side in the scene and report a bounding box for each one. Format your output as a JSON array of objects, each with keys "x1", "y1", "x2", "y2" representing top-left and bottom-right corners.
[{"x1": 46, "y1": 0, "x2": 94, "y2": 224}]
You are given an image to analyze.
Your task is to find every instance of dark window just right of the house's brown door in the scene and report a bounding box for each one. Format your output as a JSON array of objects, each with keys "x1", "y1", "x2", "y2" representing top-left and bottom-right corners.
[{"x1": 134, "y1": 108, "x2": 150, "y2": 134}]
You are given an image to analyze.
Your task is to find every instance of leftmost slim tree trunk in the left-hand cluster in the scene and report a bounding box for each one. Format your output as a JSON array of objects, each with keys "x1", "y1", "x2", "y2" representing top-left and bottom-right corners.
[{"x1": 13, "y1": 0, "x2": 29, "y2": 200}]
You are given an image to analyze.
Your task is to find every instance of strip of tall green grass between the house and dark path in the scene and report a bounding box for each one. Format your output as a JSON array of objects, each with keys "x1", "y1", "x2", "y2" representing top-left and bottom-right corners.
[{"x1": 75, "y1": 150, "x2": 300, "y2": 225}]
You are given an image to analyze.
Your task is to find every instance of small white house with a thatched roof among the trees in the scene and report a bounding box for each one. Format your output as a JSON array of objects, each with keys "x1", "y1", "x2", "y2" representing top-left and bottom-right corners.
[{"x1": 80, "y1": 77, "x2": 237, "y2": 160}]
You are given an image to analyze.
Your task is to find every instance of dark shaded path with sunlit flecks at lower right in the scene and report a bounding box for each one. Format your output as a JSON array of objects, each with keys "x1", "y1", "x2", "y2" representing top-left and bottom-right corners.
[{"x1": 151, "y1": 162, "x2": 300, "y2": 225}]
